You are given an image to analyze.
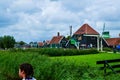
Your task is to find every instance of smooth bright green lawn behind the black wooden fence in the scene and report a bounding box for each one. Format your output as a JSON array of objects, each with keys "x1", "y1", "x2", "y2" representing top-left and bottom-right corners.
[{"x1": 51, "y1": 53, "x2": 120, "y2": 67}]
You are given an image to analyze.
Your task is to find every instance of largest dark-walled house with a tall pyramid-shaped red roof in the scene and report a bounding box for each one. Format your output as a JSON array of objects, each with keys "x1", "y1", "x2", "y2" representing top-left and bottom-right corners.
[{"x1": 70, "y1": 24, "x2": 100, "y2": 48}]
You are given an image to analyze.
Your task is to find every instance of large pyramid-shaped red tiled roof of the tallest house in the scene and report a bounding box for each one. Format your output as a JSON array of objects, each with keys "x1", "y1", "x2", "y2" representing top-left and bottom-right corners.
[{"x1": 74, "y1": 24, "x2": 99, "y2": 35}]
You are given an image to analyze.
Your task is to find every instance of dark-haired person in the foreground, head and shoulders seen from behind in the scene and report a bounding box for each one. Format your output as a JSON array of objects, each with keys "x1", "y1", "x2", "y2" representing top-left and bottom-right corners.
[{"x1": 19, "y1": 63, "x2": 36, "y2": 80}]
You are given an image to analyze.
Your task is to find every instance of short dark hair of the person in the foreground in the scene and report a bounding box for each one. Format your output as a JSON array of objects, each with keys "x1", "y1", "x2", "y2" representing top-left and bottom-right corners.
[{"x1": 20, "y1": 63, "x2": 34, "y2": 78}]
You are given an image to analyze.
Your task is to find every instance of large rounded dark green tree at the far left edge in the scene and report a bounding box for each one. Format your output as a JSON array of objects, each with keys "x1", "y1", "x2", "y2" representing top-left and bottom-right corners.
[{"x1": 0, "y1": 35, "x2": 15, "y2": 49}]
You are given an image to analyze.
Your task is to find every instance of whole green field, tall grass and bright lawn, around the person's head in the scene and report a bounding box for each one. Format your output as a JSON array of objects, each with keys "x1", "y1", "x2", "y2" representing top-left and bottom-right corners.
[{"x1": 0, "y1": 51, "x2": 120, "y2": 80}]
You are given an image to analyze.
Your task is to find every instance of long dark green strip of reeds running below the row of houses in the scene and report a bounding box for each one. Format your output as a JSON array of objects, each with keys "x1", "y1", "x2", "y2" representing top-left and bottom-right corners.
[{"x1": 7, "y1": 48, "x2": 99, "y2": 56}]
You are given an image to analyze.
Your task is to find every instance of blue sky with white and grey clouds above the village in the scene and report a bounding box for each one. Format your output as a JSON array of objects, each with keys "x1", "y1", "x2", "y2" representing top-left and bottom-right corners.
[{"x1": 0, "y1": 0, "x2": 120, "y2": 42}]
